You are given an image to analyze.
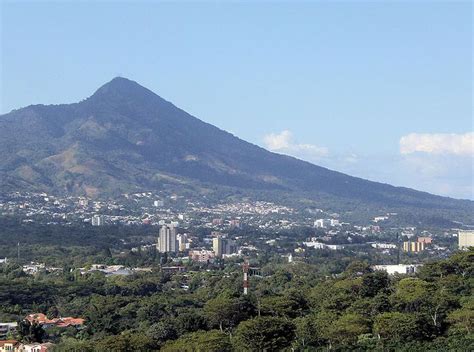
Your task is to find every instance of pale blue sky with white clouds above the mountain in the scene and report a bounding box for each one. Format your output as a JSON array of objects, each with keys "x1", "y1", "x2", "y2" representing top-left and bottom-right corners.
[{"x1": 0, "y1": 1, "x2": 474, "y2": 199}]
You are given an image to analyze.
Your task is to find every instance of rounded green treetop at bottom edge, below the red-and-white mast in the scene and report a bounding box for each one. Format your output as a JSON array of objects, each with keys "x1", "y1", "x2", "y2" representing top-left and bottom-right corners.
[{"x1": 233, "y1": 317, "x2": 295, "y2": 351}]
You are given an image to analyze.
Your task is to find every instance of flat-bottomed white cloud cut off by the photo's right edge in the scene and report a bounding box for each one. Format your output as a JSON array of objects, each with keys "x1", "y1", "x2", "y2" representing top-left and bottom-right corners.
[{"x1": 400, "y1": 132, "x2": 474, "y2": 155}]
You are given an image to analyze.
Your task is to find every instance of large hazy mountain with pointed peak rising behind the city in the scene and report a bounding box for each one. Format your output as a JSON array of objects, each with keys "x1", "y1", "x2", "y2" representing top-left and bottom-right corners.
[{"x1": 0, "y1": 78, "x2": 473, "y2": 217}]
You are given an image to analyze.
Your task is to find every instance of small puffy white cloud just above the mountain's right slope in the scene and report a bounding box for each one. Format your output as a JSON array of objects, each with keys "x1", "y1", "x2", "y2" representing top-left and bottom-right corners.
[{"x1": 263, "y1": 130, "x2": 329, "y2": 161}]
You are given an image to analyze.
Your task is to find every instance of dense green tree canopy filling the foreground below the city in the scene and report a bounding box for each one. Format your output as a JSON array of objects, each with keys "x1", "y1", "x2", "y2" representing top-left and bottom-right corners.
[{"x1": 0, "y1": 249, "x2": 474, "y2": 352}]
